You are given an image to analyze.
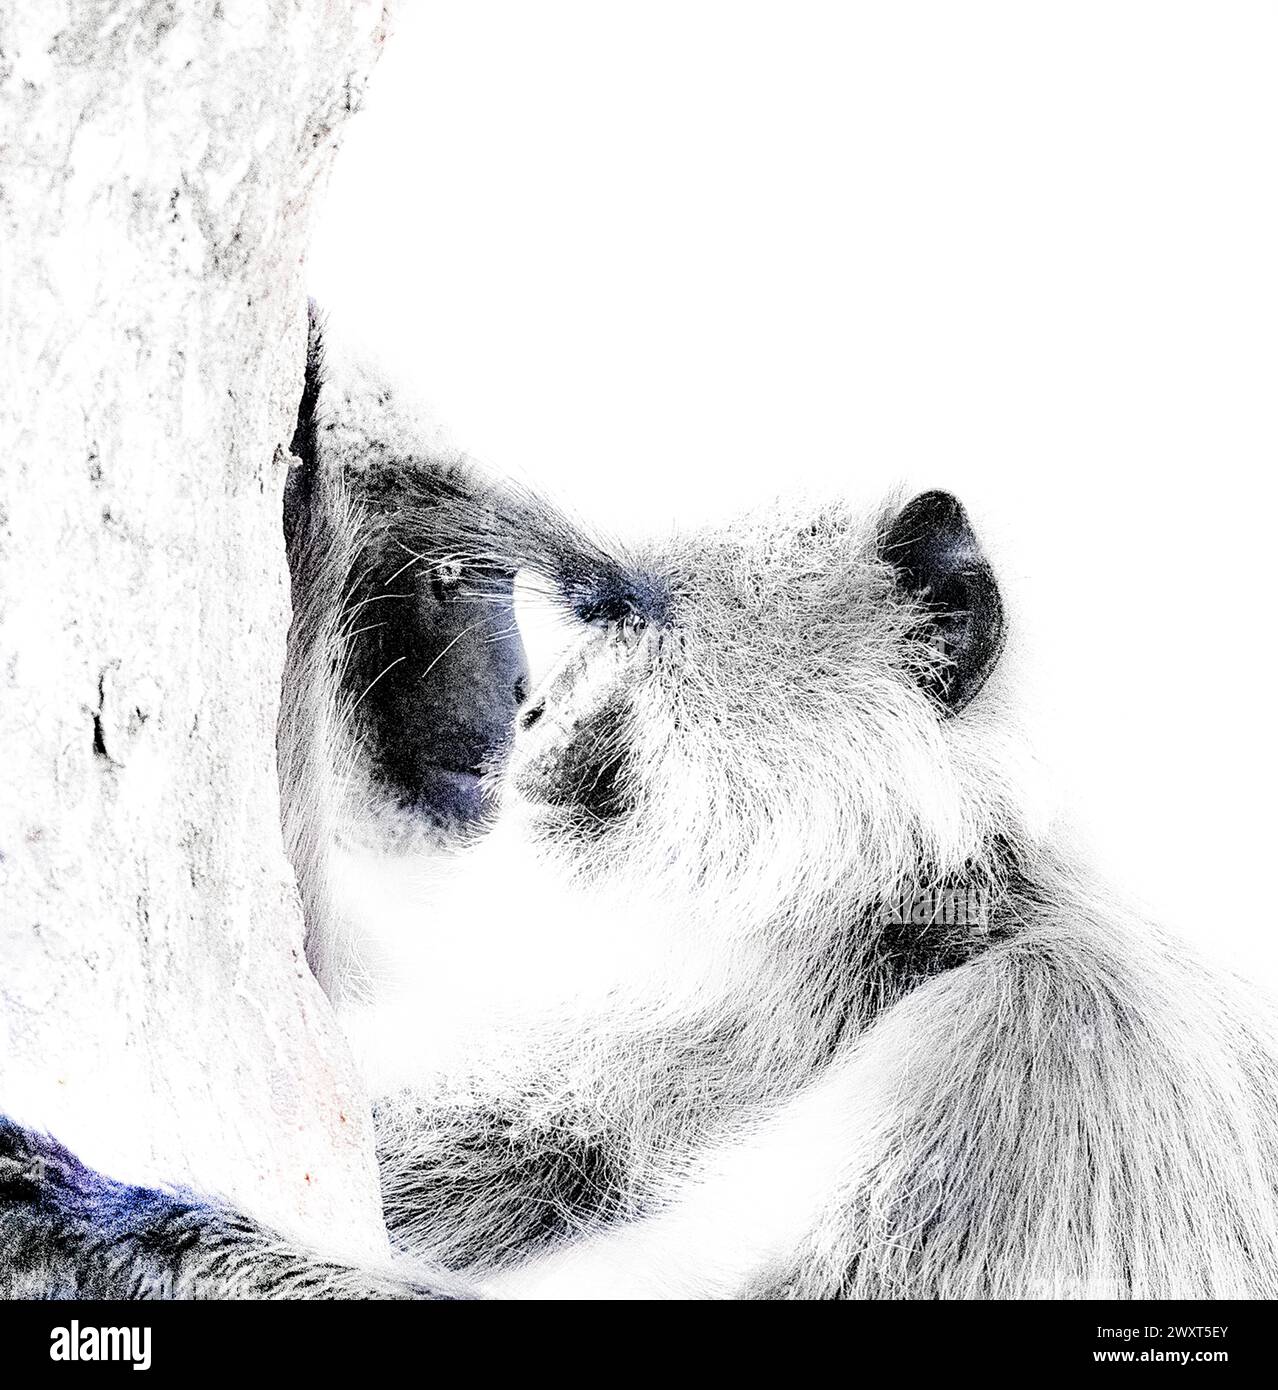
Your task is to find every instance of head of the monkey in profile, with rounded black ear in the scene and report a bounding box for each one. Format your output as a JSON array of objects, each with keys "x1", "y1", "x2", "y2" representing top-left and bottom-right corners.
[{"x1": 508, "y1": 492, "x2": 1017, "y2": 922}]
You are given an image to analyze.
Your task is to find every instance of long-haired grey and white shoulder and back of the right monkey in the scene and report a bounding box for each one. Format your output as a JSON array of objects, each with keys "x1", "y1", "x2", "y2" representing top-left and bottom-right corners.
[{"x1": 759, "y1": 861, "x2": 1278, "y2": 1298}]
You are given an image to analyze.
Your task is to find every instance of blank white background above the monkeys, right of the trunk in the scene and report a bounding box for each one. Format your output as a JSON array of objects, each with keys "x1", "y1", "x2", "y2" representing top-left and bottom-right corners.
[{"x1": 310, "y1": 8, "x2": 1278, "y2": 986}]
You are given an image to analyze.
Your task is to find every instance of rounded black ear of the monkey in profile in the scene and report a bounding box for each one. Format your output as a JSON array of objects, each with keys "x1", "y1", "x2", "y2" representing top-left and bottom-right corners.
[{"x1": 880, "y1": 492, "x2": 1003, "y2": 714}]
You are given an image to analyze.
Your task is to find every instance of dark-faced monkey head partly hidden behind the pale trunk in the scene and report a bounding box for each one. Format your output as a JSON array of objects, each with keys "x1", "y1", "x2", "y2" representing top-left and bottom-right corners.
[{"x1": 281, "y1": 312, "x2": 528, "y2": 848}]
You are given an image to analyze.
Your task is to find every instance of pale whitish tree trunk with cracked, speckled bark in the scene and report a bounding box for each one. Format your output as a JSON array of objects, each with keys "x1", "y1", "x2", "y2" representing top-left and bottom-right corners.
[{"x1": 0, "y1": 0, "x2": 394, "y2": 1251}]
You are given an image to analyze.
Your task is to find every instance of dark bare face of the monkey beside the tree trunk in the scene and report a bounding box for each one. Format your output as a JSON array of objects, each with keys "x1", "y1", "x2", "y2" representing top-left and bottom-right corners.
[{"x1": 343, "y1": 555, "x2": 528, "y2": 835}]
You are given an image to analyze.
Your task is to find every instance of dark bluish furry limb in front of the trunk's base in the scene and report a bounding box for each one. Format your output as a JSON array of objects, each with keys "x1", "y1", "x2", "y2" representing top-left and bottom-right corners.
[{"x1": 0, "y1": 1116, "x2": 466, "y2": 1300}]
